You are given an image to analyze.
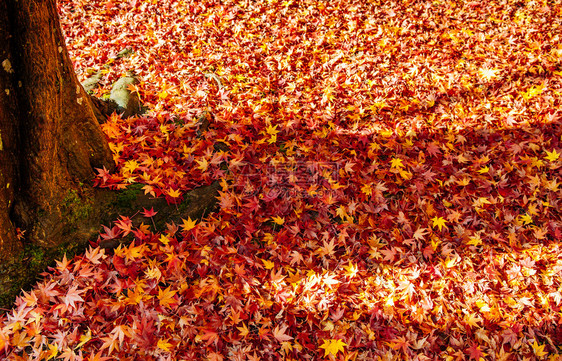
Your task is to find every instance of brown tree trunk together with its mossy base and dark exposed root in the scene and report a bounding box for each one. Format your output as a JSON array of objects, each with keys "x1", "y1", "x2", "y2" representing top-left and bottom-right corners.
[{"x1": 0, "y1": 0, "x2": 218, "y2": 307}]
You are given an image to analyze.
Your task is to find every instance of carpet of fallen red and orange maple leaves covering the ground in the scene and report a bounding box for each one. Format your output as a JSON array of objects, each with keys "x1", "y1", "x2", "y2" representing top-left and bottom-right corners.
[{"x1": 0, "y1": 0, "x2": 562, "y2": 361}]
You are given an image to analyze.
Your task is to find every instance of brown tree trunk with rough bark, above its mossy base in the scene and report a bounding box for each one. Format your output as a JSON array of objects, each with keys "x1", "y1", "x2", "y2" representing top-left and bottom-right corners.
[{"x1": 0, "y1": 0, "x2": 114, "y2": 258}]
